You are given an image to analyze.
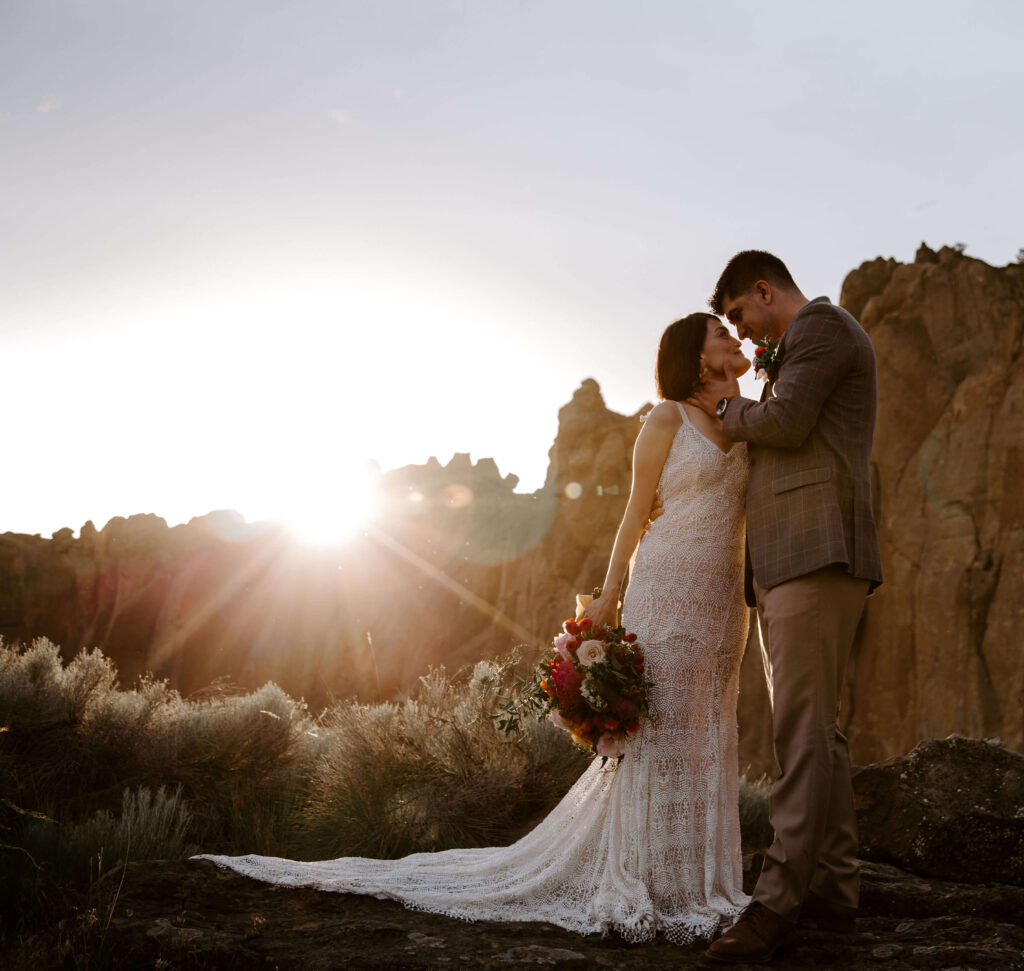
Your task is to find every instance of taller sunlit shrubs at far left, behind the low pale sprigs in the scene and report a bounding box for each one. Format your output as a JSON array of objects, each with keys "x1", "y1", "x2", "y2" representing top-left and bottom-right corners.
[{"x1": 0, "y1": 639, "x2": 317, "y2": 853}]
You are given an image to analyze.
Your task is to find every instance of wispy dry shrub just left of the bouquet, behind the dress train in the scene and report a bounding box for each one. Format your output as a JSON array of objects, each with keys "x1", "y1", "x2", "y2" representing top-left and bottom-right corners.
[{"x1": 303, "y1": 662, "x2": 589, "y2": 857}]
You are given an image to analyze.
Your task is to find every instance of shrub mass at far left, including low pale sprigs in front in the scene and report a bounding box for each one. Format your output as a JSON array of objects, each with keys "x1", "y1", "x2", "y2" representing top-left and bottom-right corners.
[{"x1": 0, "y1": 640, "x2": 318, "y2": 946}]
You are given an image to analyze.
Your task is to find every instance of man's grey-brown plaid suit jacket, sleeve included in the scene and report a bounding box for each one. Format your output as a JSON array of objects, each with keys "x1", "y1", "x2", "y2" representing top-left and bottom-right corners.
[{"x1": 723, "y1": 297, "x2": 882, "y2": 602}]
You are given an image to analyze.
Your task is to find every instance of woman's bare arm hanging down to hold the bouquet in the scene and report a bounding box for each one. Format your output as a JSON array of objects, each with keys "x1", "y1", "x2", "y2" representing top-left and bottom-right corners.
[{"x1": 585, "y1": 402, "x2": 682, "y2": 627}]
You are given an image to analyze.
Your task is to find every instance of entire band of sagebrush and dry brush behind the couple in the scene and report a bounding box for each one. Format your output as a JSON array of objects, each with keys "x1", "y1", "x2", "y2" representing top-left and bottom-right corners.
[{"x1": 0, "y1": 639, "x2": 770, "y2": 950}]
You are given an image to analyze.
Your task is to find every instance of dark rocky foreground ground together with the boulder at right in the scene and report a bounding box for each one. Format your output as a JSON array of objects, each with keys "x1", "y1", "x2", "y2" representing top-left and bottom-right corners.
[{"x1": 72, "y1": 735, "x2": 1024, "y2": 971}]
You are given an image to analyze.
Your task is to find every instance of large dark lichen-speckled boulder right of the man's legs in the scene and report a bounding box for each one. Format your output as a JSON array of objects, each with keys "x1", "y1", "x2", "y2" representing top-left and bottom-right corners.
[{"x1": 853, "y1": 735, "x2": 1024, "y2": 886}]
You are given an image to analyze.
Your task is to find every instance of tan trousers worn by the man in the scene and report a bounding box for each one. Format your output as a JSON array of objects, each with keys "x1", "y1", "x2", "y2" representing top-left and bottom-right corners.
[{"x1": 754, "y1": 565, "x2": 869, "y2": 920}]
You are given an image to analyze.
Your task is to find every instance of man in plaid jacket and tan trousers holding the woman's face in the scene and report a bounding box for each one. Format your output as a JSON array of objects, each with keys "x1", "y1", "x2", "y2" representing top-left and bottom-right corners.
[{"x1": 691, "y1": 250, "x2": 882, "y2": 964}]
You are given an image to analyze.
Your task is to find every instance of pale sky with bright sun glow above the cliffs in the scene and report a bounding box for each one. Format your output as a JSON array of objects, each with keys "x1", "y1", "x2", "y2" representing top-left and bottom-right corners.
[{"x1": 0, "y1": 0, "x2": 1024, "y2": 536}]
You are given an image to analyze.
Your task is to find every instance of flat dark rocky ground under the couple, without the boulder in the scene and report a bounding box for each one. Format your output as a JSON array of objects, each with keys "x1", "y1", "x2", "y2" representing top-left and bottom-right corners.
[{"x1": 75, "y1": 858, "x2": 1024, "y2": 971}]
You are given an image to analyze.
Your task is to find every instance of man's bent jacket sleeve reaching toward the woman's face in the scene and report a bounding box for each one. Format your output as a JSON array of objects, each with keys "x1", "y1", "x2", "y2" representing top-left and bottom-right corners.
[{"x1": 722, "y1": 313, "x2": 855, "y2": 449}]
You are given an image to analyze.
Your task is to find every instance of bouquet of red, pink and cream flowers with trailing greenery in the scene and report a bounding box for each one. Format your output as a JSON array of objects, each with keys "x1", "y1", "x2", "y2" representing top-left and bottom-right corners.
[{"x1": 495, "y1": 618, "x2": 649, "y2": 759}]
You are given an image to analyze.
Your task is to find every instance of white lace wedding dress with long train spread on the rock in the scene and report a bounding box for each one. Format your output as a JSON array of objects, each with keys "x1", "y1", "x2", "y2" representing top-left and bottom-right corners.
[{"x1": 200, "y1": 408, "x2": 749, "y2": 943}]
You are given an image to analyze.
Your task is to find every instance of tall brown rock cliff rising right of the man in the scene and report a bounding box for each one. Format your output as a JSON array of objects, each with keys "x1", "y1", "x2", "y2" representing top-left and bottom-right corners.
[{"x1": 842, "y1": 245, "x2": 1024, "y2": 762}]
